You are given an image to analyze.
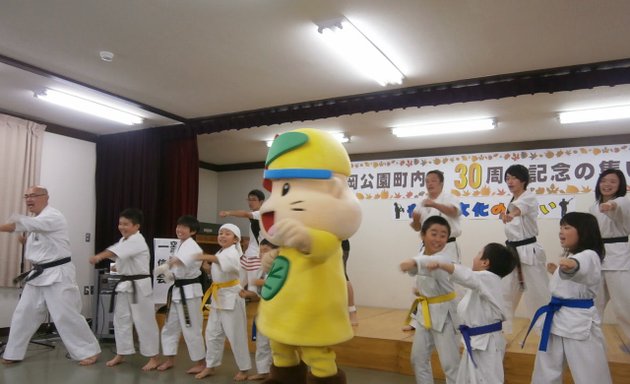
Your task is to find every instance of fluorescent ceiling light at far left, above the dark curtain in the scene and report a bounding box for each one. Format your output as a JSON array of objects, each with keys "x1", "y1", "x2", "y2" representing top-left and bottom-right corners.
[{"x1": 35, "y1": 89, "x2": 144, "y2": 125}]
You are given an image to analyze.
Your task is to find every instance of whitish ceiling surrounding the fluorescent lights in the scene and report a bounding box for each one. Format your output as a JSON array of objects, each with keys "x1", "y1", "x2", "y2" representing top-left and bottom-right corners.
[{"x1": 0, "y1": 0, "x2": 630, "y2": 165}]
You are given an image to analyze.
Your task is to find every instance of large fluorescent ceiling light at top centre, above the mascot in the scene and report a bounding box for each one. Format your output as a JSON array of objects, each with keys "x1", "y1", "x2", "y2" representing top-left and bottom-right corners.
[{"x1": 317, "y1": 17, "x2": 405, "y2": 86}]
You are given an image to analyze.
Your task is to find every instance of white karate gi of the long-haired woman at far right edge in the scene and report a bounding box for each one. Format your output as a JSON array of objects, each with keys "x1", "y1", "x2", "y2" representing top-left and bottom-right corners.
[{"x1": 589, "y1": 196, "x2": 630, "y2": 340}]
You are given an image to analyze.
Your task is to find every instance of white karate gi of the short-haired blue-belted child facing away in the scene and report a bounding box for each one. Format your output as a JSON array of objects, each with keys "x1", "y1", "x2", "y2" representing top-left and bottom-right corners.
[{"x1": 452, "y1": 265, "x2": 506, "y2": 384}]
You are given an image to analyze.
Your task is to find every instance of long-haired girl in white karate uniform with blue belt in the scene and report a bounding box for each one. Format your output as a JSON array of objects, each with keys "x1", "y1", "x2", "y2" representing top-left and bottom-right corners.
[{"x1": 523, "y1": 212, "x2": 612, "y2": 384}]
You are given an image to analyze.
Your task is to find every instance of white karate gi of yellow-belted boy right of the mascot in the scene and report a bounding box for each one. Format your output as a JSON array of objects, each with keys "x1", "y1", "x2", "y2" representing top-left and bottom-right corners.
[{"x1": 409, "y1": 253, "x2": 459, "y2": 384}]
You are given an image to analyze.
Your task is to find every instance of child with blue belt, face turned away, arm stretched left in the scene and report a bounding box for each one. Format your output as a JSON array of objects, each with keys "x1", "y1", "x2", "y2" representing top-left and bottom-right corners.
[{"x1": 426, "y1": 243, "x2": 518, "y2": 384}]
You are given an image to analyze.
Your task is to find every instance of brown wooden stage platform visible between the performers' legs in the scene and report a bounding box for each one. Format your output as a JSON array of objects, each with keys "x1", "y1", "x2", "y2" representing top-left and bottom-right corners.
[{"x1": 334, "y1": 307, "x2": 630, "y2": 384}]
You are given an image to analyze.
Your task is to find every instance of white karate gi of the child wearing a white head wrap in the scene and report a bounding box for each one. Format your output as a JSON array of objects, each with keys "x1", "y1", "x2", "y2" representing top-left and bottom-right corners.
[{"x1": 206, "y1": 245, "x2": 252, "y2": 371}]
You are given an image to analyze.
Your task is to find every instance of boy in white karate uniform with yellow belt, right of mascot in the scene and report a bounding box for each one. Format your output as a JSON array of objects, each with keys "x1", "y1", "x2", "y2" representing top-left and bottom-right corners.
[{"x1": 400, "y1": 216, "x2": 459, "y2": 384}]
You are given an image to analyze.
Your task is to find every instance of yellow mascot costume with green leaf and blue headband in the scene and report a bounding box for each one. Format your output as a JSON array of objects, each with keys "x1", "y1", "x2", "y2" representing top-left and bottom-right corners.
[{"x1": 256, "y1": 128, "x2": 361, "y2": 384}]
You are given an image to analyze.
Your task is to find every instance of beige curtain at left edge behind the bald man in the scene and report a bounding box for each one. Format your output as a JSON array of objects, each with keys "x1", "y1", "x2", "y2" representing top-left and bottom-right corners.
[{"x1": 0, "y1": 114, "x2": 46, "y2": 287}]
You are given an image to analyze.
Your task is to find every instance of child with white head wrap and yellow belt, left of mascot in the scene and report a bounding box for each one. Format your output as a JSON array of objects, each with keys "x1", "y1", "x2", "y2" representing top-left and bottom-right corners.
[{"x1": 195, "y1": 224, "x2": 252, "y2": 381}]
